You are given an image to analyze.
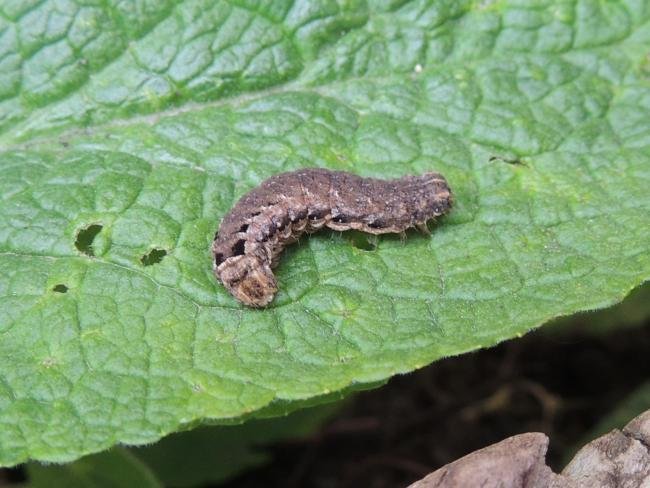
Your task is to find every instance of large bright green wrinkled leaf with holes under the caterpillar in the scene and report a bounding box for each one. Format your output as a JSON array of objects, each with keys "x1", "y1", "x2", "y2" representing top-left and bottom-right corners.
[{"x1": 0, "y1": 0, "x2": 650, "y2": 465}]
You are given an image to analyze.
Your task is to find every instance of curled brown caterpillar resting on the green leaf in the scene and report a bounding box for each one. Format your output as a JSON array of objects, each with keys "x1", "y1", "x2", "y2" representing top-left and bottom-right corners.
[{"x1": 212, "y1": 168, "x2": 452, "y2": 307}]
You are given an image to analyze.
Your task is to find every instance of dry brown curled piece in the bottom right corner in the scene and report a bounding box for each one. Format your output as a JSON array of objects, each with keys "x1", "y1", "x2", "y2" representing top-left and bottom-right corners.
[{"x1": 410, "y1": 410, "x2": 650, "y2": 488}]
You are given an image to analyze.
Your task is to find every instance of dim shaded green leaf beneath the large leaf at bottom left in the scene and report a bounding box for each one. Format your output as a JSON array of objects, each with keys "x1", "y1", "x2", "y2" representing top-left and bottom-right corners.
[{"x1": 27, "y1": 402, "x2": 345, "y2": 488}]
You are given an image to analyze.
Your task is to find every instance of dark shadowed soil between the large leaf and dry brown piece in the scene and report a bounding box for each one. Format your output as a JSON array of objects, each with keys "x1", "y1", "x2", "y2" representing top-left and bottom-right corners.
[{"x1": 226, "y1": 326, "x2": 650, "y2": 488}]
